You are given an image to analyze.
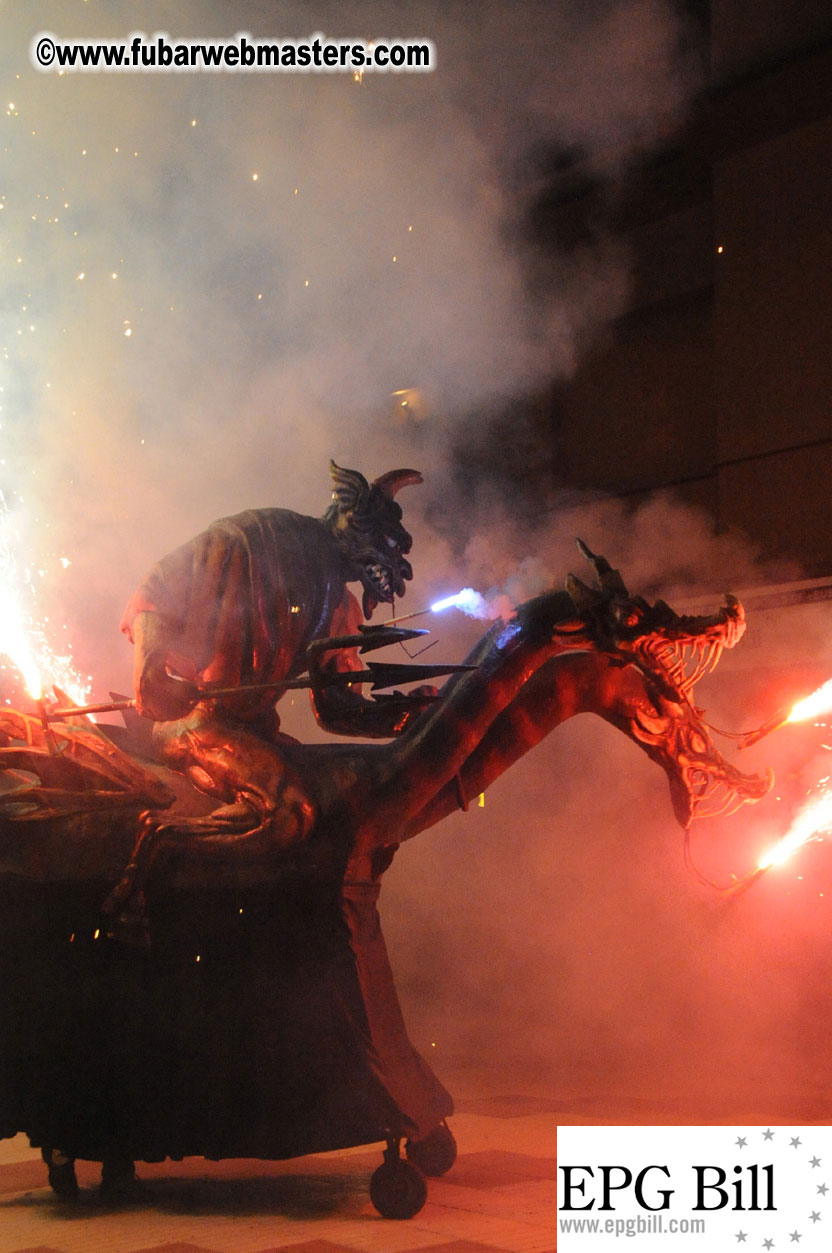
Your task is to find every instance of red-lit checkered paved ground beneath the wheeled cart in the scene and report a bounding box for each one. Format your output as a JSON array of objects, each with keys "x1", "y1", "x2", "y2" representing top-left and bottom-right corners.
[{"x1": 0, "y1": 1076, "x2": 563, "y2": 1253}]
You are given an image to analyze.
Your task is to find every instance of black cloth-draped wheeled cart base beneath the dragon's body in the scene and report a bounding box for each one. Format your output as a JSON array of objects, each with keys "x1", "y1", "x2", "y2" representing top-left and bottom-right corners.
[{"x1": 0, "y1": 812, "x2": 456, "y2": 1218}]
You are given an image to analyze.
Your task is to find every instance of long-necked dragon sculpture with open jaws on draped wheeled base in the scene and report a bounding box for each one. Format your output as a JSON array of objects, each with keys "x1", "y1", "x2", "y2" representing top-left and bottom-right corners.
[{"x1": 0, "y1": 545, "x2": 772, "y2": 1212}]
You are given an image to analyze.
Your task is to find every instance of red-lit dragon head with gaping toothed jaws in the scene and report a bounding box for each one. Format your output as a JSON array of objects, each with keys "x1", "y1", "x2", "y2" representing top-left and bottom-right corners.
[{"x1": 564, "y1": 540, "x2": 773, "y2": 828}]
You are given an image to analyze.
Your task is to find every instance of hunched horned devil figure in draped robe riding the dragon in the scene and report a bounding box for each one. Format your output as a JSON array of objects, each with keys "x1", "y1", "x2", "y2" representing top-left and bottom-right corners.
[{"x1": 122, "y1": 462, "x2": 422, "y2": 842}]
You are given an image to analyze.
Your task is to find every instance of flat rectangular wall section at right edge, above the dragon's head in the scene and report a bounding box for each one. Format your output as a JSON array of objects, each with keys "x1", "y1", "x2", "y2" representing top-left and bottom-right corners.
[{"x1": 714, "y1": 117, "x2": 832, "y2": 570}]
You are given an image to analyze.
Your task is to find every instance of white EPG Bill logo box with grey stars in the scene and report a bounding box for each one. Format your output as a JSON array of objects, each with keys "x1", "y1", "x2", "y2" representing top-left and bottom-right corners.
[{"x1": 558, "y1": 1126, "x2": 832, "y2": 1253}]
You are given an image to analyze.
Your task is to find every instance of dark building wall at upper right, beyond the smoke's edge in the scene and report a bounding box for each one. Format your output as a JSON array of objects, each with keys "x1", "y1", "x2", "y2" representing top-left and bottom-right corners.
[{"x1": 553, "y1": 13, "x2": 832, "y2": 575}]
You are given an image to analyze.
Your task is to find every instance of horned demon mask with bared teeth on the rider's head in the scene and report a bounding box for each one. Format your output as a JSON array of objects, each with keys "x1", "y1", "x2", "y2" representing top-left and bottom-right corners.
[{"x1": 323, "y1": 461, "x2": 424, "y2": 618}]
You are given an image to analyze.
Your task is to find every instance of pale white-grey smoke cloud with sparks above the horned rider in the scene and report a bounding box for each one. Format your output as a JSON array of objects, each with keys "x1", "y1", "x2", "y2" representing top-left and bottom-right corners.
[{"x1": 0, "y1": 0, "x2": 694, "y2": 684}]
